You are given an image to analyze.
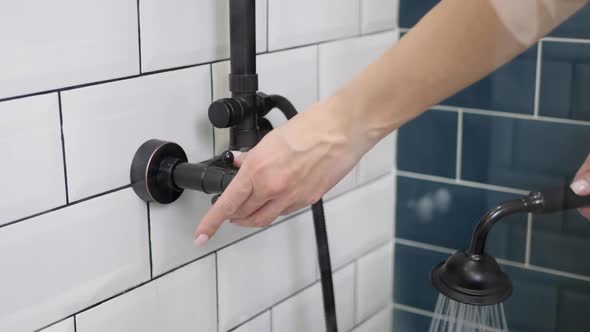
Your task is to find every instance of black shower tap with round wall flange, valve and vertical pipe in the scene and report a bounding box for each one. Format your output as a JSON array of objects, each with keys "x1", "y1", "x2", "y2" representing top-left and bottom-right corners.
[{"x1": 130, "y1": 0, "x2": 276, "y2": 204}]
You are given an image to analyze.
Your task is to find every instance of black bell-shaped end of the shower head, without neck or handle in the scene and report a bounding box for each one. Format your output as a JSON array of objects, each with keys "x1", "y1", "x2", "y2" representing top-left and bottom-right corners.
[{"x1": 430, "y1": 251, "x2": 512, "y2": 305}]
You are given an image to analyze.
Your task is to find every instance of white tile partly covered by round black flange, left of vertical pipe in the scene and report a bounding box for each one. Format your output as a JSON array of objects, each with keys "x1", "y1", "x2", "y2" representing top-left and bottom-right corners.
[{"x1": 62, "y1": 66, "x2": 213, "y2": 200}]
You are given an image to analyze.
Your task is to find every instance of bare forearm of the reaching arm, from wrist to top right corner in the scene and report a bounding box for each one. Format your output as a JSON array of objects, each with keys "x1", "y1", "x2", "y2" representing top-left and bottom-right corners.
[{"x1": 326, "y1": 0, "x2": 587, "y2": 146}]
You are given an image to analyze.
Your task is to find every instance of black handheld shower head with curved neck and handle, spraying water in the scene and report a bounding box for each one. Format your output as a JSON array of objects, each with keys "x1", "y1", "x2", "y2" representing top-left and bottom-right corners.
[{"x1": 430, "y1": 187, "x2": 590, "y2": 305}]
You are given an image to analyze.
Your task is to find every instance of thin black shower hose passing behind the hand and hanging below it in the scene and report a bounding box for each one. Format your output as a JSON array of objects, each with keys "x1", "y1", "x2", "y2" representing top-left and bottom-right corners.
[{"x1": 268, "y1": 95, "x2": 338, "y2": 332}]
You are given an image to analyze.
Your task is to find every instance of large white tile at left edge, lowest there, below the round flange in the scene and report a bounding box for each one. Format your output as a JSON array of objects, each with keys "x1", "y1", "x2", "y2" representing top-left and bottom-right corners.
[{"x1": 0, "y1": 189, "x2": 150, "y2": 332}]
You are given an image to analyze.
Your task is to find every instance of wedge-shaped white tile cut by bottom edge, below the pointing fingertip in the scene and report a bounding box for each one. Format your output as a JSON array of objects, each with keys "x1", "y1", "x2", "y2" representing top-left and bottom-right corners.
[{"x1": 76, "y1": 255, "x2": 217, "y2": 332}]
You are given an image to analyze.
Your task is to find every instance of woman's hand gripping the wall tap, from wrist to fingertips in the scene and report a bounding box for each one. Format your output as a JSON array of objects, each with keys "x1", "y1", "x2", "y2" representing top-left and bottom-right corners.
[{"x1": 195, "y1": 101, "x2": 376, "y2": 245}]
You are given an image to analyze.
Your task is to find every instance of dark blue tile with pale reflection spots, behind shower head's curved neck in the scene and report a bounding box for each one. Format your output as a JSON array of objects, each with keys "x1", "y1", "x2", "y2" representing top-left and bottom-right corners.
[{"x1": 395, "y1": 177, "x2": 527, "y2": 262}]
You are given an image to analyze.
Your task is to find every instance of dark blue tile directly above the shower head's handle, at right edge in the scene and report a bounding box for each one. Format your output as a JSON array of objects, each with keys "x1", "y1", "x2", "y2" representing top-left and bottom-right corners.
[{"x1": 462, "y1": 114, "x2": 590, "y2": 190}]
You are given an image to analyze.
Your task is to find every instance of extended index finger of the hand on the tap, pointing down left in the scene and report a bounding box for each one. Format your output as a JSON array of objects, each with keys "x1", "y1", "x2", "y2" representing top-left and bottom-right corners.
[{"x1": 195, "y1": 172, "x2": 252, "y2": 246}]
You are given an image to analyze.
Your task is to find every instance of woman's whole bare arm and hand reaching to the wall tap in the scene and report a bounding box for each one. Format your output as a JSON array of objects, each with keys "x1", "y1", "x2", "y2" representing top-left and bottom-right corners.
[{"x1": 195, "y1": 0, "x2": 586, "y2": 245}]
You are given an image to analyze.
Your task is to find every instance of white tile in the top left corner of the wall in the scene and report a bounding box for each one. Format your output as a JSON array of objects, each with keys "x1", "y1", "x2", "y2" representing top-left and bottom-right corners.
[{"x1": 0, "y1": 0, "x2": 139, "y2": 99}]
